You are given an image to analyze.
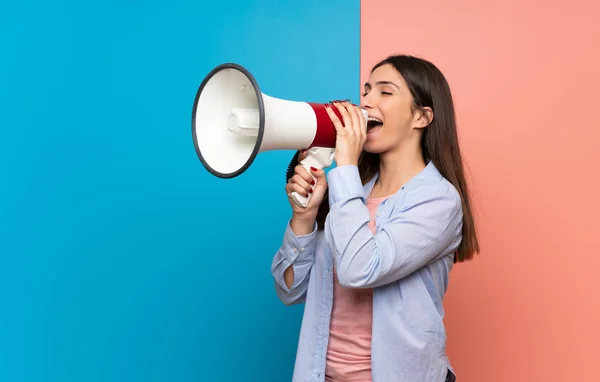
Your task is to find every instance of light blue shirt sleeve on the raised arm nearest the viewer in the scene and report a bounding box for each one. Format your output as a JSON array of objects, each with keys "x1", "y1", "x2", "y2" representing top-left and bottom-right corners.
[{"x1": 325, "y1": 166, "x2": 462, "y2": 288}]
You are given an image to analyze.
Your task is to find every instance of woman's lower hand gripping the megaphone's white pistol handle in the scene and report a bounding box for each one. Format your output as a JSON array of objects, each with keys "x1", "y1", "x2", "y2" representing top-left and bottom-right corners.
[{"x1": 285, "y1": 152, "x2": 327, "y2": 225}]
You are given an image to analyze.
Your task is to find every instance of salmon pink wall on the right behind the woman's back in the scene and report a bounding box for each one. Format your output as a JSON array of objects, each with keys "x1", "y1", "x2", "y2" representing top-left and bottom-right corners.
[{"x1": 361, "y1": 0, "x2": 600, "y2": 382}]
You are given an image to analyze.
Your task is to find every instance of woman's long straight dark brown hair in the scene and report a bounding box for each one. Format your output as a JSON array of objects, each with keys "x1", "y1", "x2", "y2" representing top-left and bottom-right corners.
[{"x1": 317, "y1": 55, "x2": 479, "y2": 262}]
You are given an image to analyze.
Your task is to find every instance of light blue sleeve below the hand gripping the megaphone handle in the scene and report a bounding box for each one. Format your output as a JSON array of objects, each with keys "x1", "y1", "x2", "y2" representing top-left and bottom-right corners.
[{"x1": 271, "y1": 221, "x2": 317, "y2": 305}]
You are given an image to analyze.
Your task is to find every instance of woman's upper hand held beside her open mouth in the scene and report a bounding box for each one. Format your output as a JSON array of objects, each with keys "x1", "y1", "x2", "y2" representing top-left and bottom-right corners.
[{"x1": 325, "y1": 102, "x2": 367, "y2": 166}]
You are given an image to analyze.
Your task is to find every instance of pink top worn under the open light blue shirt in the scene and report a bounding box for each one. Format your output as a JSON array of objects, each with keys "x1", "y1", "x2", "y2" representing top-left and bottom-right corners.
[{"x1": 325, "y1": 197, "x2": 385, "y2": 382}]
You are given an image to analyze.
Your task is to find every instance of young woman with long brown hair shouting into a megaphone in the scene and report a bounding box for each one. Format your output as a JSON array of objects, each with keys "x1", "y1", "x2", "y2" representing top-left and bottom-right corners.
[{"x1": 272, "y1": 55, "x2": 479, "y2": 382}]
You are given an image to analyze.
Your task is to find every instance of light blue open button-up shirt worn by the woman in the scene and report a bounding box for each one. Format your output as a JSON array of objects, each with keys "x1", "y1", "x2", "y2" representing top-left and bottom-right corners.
[{"x1": 271, "y1": 162, "x2": 462, "y2": 382}]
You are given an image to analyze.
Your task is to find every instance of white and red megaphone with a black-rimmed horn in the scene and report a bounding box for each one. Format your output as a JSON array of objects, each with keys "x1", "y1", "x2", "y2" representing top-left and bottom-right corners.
[{"x1": 192, "y1": 63, "x2": 367, "y2": 207}]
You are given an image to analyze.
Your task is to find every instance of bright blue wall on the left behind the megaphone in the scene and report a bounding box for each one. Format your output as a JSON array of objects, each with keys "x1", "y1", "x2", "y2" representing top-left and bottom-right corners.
[{"x1": 0, "y1": 0, "x2": 360, "y2": 382}]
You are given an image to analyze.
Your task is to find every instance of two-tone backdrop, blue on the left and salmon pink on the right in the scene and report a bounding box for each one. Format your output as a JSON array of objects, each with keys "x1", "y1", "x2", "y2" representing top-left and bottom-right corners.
[{"x1": 0, "y1": 0, "x2": 600, "y2": 382}]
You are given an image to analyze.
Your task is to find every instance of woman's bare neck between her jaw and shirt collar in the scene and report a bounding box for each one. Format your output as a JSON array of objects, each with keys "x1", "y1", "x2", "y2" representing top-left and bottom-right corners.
[{"x1": 372, "y1": 142, "x2": 426, "y2": 197}]
